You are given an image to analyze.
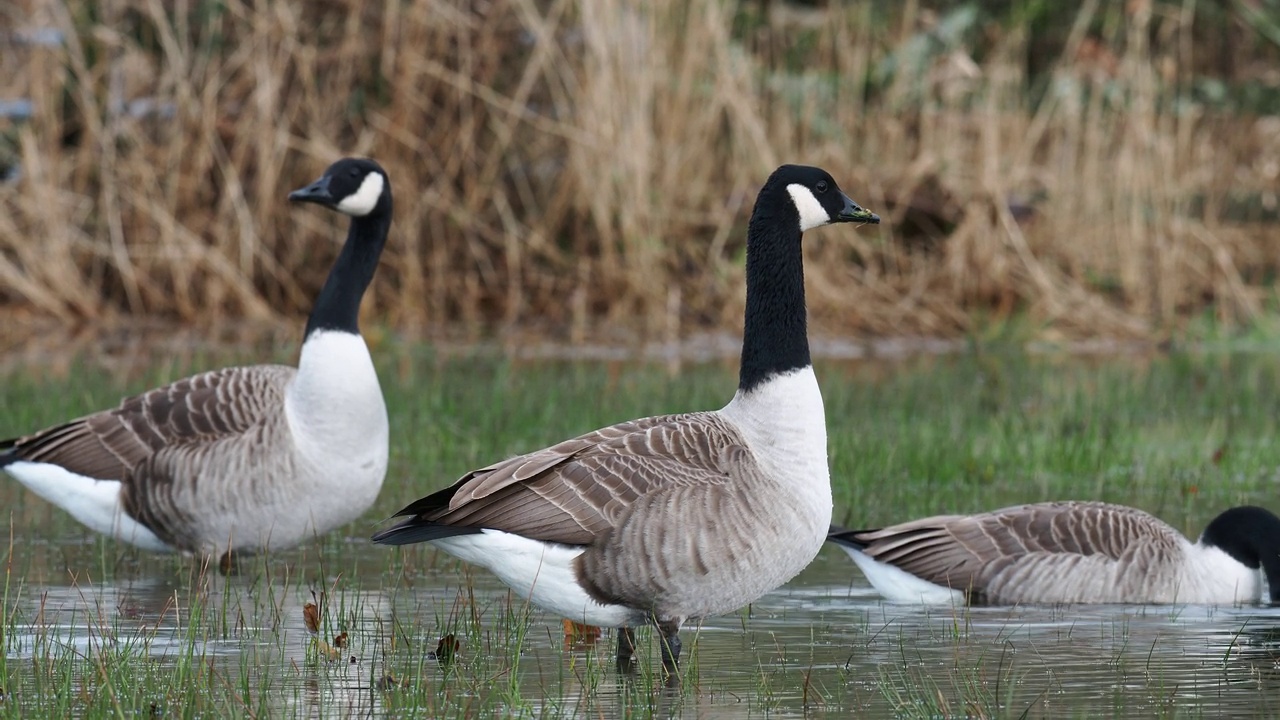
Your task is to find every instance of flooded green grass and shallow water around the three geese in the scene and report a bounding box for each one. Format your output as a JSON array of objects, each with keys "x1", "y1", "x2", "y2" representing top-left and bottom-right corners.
[{"x1": 0, "y1": 347, "x2": 1280, "y2": 717}]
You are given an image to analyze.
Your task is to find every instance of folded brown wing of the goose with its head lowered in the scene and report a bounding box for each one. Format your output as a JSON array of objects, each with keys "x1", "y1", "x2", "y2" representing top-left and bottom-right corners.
[{"x1": 846, "y1": 502, "x2": 1180, "y2": 602}]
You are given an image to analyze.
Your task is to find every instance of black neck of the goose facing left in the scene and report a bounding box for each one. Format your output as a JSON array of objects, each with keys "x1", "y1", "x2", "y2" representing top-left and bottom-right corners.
[{"x1": 305, "y1": 211, "x2": 392, "y2": 337}]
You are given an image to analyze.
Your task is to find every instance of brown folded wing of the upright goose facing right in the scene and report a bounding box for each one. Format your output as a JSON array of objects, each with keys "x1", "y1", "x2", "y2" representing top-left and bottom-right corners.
[{"x1": 374, "y1": 413, "x2": 746, "y2": 544}]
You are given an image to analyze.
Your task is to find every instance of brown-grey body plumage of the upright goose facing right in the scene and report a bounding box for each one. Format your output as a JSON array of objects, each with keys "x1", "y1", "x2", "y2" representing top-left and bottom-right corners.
[{"x1": 375, "y1": 411, "x2": 831, "y2": 618}]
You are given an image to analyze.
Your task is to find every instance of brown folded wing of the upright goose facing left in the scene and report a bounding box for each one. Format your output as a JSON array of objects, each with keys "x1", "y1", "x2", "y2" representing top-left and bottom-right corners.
[{"x1": 9, "y1": 365, "x2": 294, "y2": 484}]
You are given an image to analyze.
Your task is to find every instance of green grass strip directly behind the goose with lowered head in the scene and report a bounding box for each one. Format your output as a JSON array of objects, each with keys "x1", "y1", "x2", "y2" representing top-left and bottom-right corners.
[{"x1": 824, "y1": 355, "x2": 1280, "y2": 533}]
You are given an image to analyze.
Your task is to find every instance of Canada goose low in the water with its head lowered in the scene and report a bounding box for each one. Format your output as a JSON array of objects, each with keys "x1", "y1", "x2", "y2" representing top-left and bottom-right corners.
[{"x1": 828, "y1": 502, "x2": 1280, "y2": 605}]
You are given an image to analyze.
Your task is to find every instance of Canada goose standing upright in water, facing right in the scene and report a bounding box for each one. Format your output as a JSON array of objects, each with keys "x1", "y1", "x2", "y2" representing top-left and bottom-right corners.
[{"x1": 374, "y1": 165, "x2": 879, "y2": 678}]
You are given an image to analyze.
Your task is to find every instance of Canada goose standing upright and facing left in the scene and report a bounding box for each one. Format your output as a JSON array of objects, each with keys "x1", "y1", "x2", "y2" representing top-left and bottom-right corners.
[{"x1": 0, "y1": 158, "x2": 392, "y2": 556}]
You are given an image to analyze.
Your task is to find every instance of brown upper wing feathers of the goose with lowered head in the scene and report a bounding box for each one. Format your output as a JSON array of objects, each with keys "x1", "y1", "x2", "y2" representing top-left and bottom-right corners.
[{"x1": 854, "y1": 502, "x2": 1169, "y2": 600}]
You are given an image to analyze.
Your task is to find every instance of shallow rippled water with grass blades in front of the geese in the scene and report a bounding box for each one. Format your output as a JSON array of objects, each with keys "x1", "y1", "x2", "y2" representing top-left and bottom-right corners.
[{"x1": 6, "y1": 540, "x2": 1280, "y2": 717}]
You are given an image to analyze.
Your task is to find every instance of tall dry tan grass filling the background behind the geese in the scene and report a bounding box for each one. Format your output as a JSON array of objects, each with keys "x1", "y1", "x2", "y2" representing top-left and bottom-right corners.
[{"x1": 0, "y1": 0, "x2": 1280, "y2": 338}]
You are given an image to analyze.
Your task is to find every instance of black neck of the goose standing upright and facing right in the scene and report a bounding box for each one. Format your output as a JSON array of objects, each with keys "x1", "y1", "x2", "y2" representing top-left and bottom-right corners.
[{"x1": 737, "y1": 204, "x2": 810, "y2": 392}]
